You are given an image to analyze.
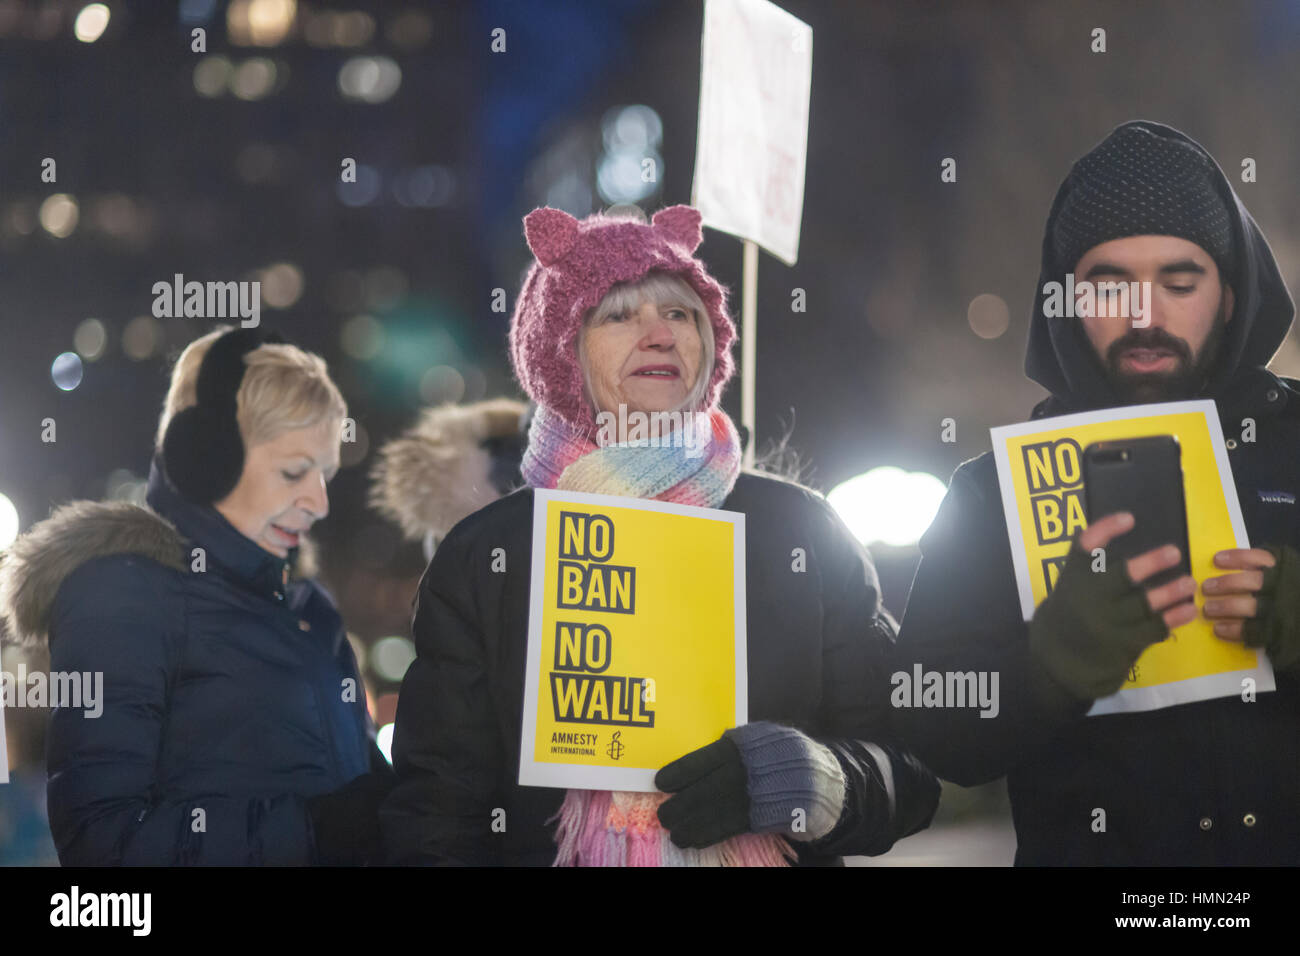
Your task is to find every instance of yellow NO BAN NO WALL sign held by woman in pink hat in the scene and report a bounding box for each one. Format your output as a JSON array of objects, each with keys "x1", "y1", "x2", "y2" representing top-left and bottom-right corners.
[{"x1": 519, "y1": 489, "x2": 748, "y2": 791}]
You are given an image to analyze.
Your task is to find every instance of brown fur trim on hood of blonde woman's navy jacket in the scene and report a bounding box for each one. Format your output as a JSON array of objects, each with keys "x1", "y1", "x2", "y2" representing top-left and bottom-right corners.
[{"x1": 0, "y1": 501, "x2": 316, "y2": 646}]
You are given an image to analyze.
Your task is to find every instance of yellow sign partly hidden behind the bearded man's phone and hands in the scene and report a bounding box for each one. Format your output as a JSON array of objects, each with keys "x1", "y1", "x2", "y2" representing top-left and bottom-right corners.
[{"x1": 991, "y1": 401, "x2": 1274, "y2": 714}]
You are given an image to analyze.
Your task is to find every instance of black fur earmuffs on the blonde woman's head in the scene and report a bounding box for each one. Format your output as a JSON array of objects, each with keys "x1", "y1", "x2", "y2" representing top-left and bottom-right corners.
[{"x1": 163, "y1": 328, "x2": 285, "y2": 505}]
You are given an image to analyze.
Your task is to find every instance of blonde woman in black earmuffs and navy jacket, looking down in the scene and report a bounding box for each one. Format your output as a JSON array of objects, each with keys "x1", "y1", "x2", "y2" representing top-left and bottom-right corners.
[{"x1": 0, "y1": 329, "x2": 391, "y2": 866}]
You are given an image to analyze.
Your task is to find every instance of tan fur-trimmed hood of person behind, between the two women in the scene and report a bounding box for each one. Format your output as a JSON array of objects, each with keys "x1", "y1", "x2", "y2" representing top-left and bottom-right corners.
[{"x1": 371, "y1": 398, "x2": 528, "y2": 541}]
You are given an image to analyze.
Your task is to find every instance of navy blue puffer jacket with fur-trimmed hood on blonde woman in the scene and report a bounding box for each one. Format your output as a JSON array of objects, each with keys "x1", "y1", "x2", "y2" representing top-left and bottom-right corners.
[{"x1": 4, "y1": 462, "x2": 382, "y2": 865}]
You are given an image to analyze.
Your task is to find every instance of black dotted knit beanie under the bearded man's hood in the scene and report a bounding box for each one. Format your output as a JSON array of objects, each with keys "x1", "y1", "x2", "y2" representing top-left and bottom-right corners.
[{"x1": 1052, "y1": 124, "x2": 1236, "y2": 281}]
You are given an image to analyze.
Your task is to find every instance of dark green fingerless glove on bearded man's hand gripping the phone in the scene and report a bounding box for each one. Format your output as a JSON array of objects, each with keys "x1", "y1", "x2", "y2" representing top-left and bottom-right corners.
[{"x1": 1030, "y1": 546, "x2": 1169, "y2": 700}]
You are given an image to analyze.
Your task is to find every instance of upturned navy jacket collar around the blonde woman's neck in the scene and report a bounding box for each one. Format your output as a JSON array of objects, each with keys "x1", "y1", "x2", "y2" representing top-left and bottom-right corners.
[{"x1": 144, "y1": 454, "x2": 296, "y2": 601}]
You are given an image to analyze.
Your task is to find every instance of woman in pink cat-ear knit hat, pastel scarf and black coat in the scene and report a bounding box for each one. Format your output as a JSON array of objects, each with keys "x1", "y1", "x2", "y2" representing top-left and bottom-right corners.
[{"x1": 381, "y1": 206, "x2": 939, "y2": 866}]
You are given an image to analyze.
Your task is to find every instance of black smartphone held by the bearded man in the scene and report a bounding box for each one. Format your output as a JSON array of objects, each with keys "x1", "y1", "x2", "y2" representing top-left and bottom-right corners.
[{"x1": 1083, "y1": 434, "x2": 1192, "y2": 588}]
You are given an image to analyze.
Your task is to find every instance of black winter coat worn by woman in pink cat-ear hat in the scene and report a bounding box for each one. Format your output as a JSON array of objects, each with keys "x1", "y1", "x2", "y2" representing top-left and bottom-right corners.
[{"x1": 380, "y1": 473, "x2": 939, "y2": 866}]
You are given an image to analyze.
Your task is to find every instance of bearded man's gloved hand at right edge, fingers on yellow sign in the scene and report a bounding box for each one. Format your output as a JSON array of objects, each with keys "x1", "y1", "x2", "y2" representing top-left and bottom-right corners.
[{"x1": 1201, "y1": 545, "x2": 1300, "y2": 670}]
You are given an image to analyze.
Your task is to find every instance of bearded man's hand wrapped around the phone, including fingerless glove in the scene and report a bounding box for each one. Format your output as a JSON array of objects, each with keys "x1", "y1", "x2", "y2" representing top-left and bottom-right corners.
[{"x1": 1030, "y1": 511, "x2": 1197, "y2": 700}]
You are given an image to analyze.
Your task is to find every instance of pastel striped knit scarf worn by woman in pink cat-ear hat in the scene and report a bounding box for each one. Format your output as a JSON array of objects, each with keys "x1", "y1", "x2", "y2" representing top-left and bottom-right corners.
[{"x1": 523, "y1": 406, "x2": 793, "y2": 866}]
